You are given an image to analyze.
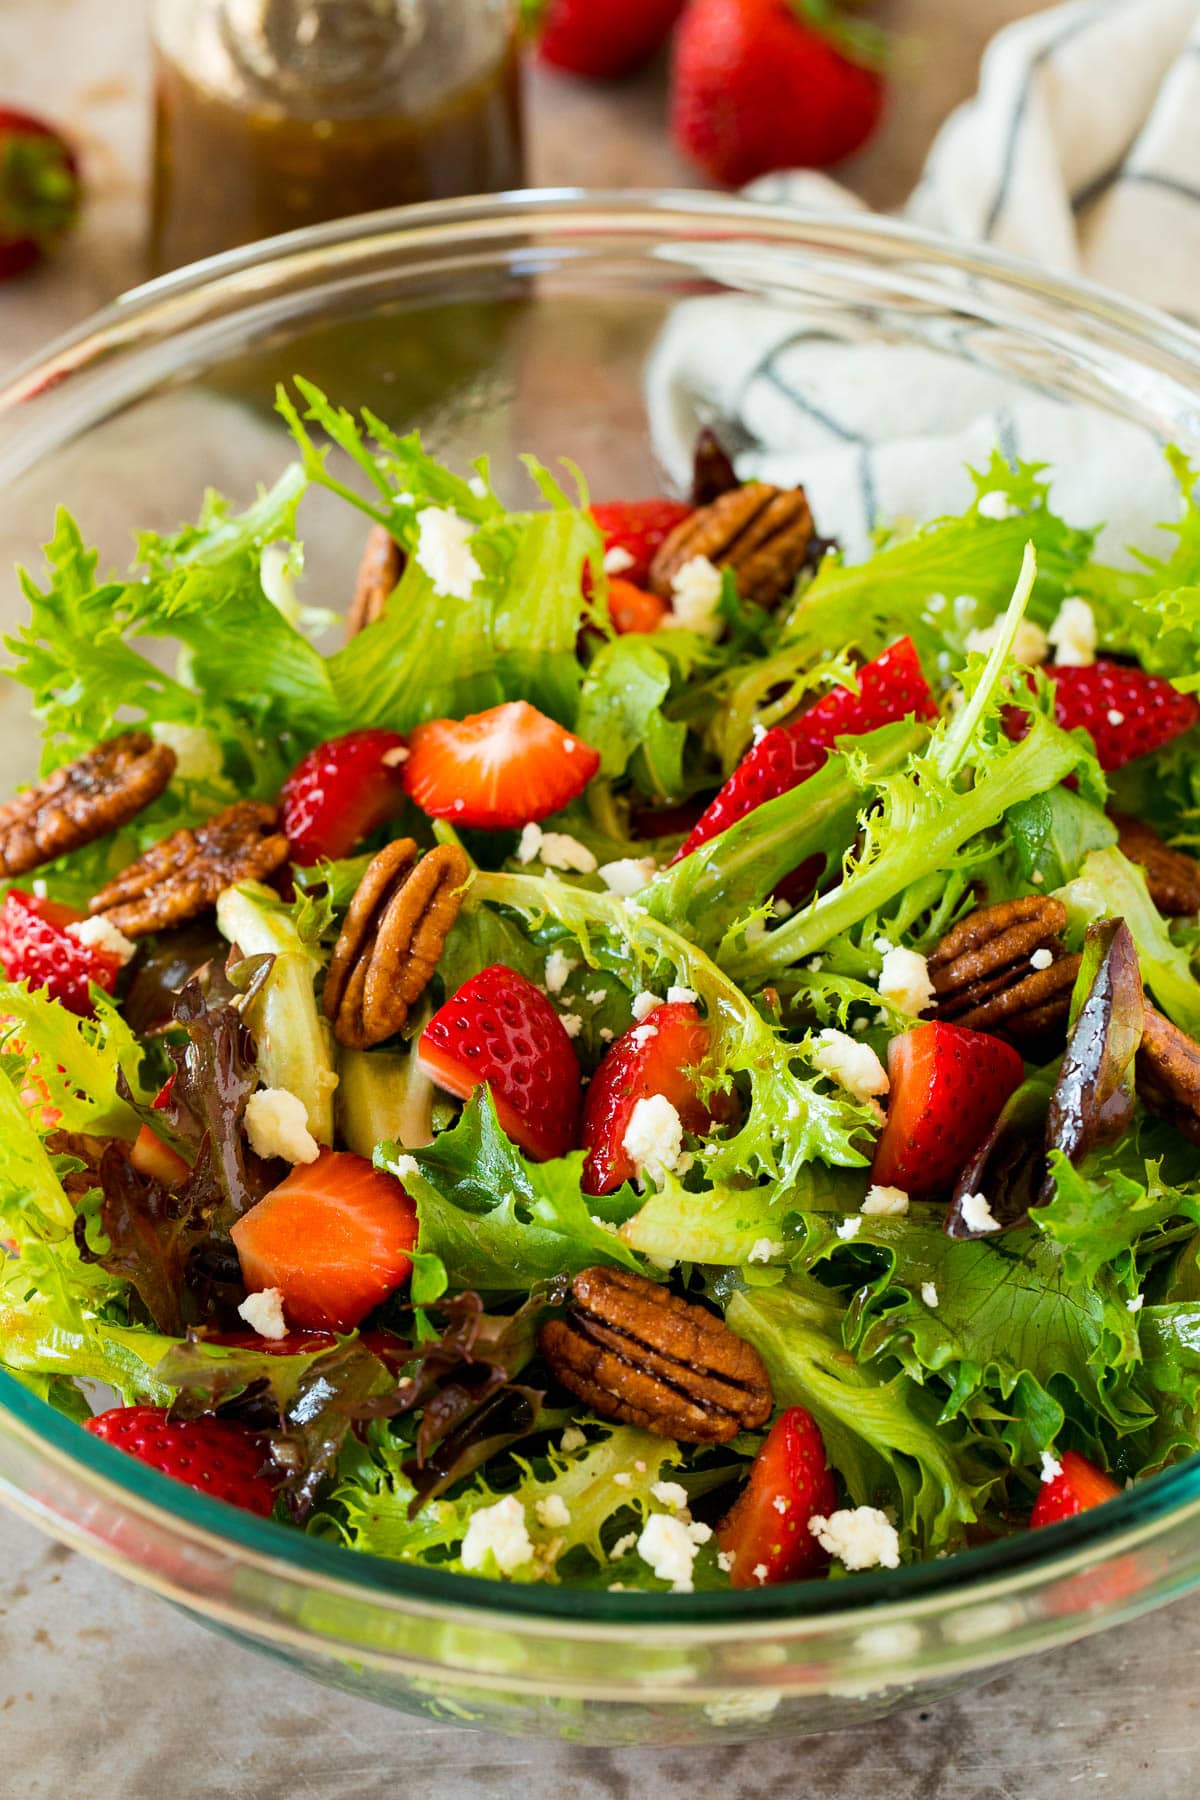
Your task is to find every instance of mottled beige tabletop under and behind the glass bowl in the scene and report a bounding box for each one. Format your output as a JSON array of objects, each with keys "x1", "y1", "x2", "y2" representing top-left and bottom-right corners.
[{"x1": 0, "y1": 0, "x2": 1200, "y2": 1800}]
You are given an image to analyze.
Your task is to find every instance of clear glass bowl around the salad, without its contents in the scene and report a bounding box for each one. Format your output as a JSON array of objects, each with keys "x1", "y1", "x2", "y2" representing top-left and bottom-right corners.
[{"x1": 0, "y1": 193, "x2": 1200, "y2": 1744}]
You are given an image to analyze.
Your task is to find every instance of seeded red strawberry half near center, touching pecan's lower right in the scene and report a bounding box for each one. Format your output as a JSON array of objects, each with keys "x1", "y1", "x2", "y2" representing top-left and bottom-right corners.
[{"x1": 417, "y1": 963, "x2": 579, "y2": 1163}]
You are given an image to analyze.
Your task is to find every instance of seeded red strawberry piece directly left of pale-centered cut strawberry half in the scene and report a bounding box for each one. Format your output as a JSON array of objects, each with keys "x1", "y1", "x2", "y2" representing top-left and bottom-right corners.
[{"x1": 279, "y1": 731, "x2": 407, "y2": 864}]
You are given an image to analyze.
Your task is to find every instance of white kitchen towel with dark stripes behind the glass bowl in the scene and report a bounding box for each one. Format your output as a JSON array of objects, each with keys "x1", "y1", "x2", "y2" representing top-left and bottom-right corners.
[{"x1": 649, "y1": 0, "x2": 1200, "y2": 554}]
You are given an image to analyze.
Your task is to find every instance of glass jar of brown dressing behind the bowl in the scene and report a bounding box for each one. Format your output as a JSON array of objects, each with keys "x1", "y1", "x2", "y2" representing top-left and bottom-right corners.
[{"x1": 149, "y1": 0, "x2": 524, "y2": 272}]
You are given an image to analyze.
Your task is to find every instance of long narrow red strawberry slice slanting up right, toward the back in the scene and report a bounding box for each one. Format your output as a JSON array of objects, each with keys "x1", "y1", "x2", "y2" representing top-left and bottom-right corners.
[{"x1": 673, "y1": 637, "x2": 937, "y2": 862}]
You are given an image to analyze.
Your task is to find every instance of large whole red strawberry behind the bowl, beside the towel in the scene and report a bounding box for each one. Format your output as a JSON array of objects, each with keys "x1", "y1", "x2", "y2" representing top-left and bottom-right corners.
[{"x1": 671, "y1": 0, "x2": 883, "y2": 187}]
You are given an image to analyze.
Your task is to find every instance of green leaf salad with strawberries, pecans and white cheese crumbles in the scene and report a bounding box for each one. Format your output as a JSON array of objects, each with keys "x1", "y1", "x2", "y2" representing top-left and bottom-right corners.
[{"x1": 0, "y1": 380, "x2": 1200, "y2": 1591}]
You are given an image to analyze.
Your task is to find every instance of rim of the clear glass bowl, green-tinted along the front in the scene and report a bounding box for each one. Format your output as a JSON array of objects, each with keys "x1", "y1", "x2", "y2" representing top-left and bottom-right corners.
[{"x1": 0, "y1": 187, "x2": 1200, "y2": 1642}]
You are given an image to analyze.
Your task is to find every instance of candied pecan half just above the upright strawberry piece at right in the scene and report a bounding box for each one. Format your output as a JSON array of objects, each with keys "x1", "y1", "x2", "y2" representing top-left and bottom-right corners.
[{"x1": 928, "y1": 895, "x2": 1079, "y2": 1044}]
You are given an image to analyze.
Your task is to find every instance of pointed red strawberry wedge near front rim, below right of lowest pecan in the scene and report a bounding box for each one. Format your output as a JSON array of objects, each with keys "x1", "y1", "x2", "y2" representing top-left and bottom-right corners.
[{"x1": 716, "y1": 1406, "x2": 838, "y2": 1588}]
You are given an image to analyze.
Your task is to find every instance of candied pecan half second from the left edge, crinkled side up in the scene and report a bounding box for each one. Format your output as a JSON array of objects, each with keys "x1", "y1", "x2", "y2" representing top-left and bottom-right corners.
[{"x1": 88, "y1": 799, "x2": 288, "y2": 938}]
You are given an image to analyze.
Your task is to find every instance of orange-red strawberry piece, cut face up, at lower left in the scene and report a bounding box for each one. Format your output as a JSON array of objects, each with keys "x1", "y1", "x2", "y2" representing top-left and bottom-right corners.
[{"x1": 230, "y1": 1150, "x2": 417, "y2": 1332}]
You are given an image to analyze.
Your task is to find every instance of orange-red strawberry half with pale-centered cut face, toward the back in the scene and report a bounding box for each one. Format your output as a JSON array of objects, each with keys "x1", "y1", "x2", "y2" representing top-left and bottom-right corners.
[{"x1": 405, "y1": 700, "x2": 599, "y2": 832}]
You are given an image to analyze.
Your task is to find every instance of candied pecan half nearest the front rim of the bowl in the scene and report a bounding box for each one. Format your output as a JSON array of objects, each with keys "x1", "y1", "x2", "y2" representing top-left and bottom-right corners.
[{"x1": 540, "y1": 1267, "x2": 774, "y2": 1444}]
